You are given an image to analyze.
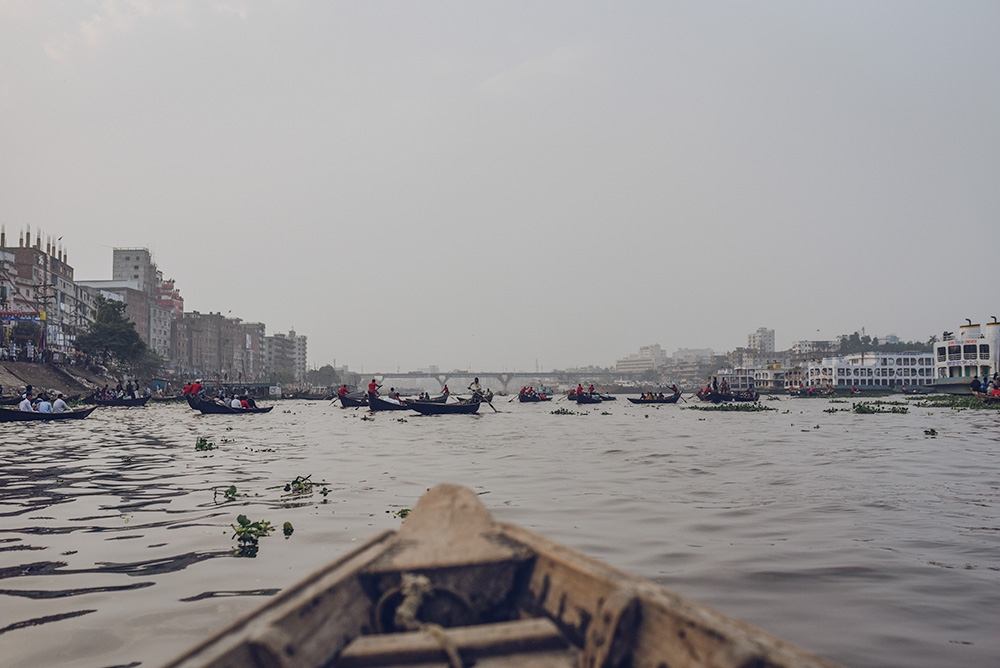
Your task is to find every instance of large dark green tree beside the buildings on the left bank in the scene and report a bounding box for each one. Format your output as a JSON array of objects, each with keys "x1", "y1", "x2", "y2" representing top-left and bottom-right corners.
[{"x1": 73, "y1": 297, "x2": 163, "y2": 375}]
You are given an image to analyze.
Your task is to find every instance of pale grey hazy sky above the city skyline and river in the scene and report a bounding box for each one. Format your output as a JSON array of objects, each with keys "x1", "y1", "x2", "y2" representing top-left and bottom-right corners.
[{"x1": 0, "y1": 0, "x2": 1000, "y2": 371}]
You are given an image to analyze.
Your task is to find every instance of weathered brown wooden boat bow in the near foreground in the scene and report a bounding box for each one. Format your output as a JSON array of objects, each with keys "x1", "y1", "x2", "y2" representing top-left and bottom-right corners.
[{"x1": 165, "y1": 485, "x2": 836, "y2": 668}]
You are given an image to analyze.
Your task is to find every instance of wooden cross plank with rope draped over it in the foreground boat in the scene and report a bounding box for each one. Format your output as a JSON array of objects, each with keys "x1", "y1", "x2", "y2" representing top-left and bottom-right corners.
[{"x1": 337, "y1": 618, "x2": 575, "y2": 668}]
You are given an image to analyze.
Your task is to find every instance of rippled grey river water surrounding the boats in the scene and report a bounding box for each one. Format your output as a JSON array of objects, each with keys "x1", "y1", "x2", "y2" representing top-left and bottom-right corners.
[{"x1": 0, "y1": 397, "x2": 1000, "y2": 668}]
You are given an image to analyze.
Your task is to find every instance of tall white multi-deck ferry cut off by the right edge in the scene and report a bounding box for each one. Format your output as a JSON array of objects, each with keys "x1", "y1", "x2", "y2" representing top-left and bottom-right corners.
[{"x1": 934, "y1": 316, "x2": 1000, "y2": 394}]
